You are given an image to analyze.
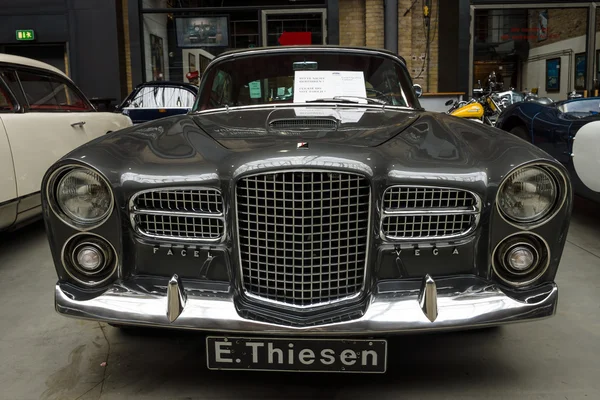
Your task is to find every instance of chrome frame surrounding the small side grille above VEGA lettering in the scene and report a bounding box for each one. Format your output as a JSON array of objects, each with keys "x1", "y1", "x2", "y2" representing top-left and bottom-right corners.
[{"x1": 379, "y1": 184, "x2": 482, "y2": 242}]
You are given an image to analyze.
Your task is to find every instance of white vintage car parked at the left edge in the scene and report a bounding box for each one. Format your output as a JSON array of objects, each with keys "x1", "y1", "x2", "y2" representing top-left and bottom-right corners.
[{"x1": 0, "y1": 54, "x2": 132, "y2": 230}]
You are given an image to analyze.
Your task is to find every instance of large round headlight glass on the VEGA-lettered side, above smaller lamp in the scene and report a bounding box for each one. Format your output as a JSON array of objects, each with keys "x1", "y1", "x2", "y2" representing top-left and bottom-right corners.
[{"x1": 498, "y1": 167, "x2": 558, "y2": 223}]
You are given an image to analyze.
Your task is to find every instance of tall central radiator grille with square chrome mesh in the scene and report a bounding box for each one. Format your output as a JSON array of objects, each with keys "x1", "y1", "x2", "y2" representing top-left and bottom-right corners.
[{"x1": 236, "y1": 171, "x2": 371, "y2": 308}]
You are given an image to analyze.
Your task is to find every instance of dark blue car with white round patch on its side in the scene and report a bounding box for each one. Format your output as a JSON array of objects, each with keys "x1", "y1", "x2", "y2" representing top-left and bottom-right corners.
[{"x1": 496, "y1": 97, "x2": 600, "y2": 202}]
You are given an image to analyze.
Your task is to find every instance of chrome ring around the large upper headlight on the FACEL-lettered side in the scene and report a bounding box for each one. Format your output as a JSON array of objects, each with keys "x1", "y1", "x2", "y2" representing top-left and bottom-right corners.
[{"x1": 46, "y1": 164, "x2": 115, "y2": 232}]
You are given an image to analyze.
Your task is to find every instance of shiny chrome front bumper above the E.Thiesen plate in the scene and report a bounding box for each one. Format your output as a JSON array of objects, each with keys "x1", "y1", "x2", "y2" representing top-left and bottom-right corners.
[{"x1": 55, "y1": 276, "x2": 558, "y2": 336}]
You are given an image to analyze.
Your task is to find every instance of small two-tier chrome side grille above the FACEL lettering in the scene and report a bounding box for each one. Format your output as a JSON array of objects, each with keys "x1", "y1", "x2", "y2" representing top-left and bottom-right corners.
[{"x1": 130, "y1": 188, "x2": 225, "y2": 242}]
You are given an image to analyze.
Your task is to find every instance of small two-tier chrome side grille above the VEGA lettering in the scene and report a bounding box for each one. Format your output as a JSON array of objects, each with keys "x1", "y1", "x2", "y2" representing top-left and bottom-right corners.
[{"x1": 381, "y1": 186, "x2": 481, "y2": 239}]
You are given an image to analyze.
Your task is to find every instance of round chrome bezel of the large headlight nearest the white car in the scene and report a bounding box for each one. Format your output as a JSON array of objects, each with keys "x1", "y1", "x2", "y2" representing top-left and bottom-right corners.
[{"x1": 46, "y1": 164, "x2": 115, "y2": 232}]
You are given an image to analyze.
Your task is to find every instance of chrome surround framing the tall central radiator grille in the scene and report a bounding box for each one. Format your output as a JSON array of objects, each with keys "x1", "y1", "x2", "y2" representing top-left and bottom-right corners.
[{"x1": 232, "y1": 168, "x2": 373, "y2": 311}]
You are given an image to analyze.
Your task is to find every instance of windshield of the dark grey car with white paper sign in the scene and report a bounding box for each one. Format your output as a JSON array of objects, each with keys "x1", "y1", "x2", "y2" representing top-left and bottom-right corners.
[{"x1": 194, "y1": 51, "x2": 420, "y2": 111}]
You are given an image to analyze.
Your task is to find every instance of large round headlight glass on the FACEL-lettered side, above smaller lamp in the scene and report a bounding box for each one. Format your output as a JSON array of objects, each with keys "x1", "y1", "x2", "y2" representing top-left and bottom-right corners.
[{"x1": 55, "y1": 168, "x2": 113, "y2": 225}]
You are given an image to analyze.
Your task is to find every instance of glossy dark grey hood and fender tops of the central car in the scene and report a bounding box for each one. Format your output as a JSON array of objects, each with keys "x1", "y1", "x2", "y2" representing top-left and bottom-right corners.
[{"x1": 59, "y1": 110, "x2": 552, "y2": 201}]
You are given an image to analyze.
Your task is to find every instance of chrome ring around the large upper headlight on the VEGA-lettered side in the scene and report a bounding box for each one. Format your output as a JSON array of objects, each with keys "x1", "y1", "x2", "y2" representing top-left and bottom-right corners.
[{"x1": 496, "y1": 162, "x2": 568, "y2": 229}]
